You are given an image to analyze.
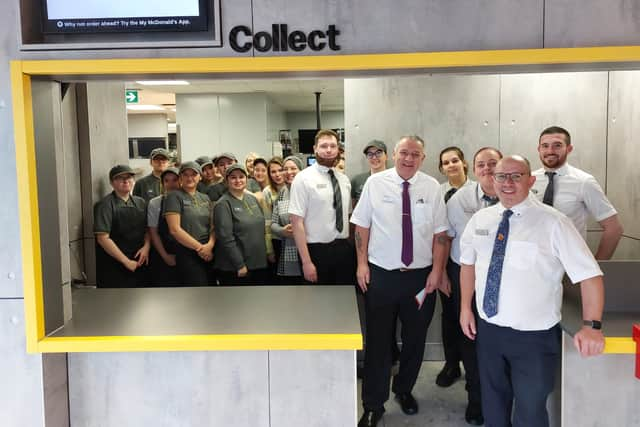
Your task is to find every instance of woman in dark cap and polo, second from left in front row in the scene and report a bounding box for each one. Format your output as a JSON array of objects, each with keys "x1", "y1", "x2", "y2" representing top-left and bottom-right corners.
[{"x1": 163, "y1": 162, "x2": 215, "y2": 286}]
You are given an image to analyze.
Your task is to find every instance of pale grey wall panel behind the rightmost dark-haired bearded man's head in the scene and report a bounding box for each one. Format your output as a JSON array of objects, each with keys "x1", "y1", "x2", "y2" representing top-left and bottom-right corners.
[{"x1": 500, "y1": 72, "x2": 608, "y2": 182}]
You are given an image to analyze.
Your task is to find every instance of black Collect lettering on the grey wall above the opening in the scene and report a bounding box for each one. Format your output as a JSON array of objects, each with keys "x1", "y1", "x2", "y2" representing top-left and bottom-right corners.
[{"x1": 229, "y1": 24, "x2": 340, "y2": 53}]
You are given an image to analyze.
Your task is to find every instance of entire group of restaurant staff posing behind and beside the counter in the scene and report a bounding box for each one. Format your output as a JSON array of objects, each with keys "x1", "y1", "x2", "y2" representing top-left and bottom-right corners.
[{"x1": 94, "y1": 126, "x2": 622, "y2": 427}]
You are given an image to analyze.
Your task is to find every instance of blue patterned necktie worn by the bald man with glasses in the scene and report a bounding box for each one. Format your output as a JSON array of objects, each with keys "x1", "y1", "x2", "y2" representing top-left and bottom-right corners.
[{"x1": 482, "y1": 209, "x2": 513, "y2": 317}]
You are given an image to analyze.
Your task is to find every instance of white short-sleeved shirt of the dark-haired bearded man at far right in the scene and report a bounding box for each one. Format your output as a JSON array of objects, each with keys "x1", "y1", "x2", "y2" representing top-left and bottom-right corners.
[{"x1": 531, "y1": 163, "x2": 617, "y2": 238}]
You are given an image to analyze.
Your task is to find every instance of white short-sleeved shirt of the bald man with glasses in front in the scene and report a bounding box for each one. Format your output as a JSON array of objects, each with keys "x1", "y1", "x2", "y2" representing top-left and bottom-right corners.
[{"x1": 460, "y1": 196, "x2": 602, "y2": 331}]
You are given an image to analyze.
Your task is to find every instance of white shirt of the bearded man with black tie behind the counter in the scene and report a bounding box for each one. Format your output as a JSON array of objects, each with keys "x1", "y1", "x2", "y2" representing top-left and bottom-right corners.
[{"x1": 289, "y1": 163, "x2": 351, "y2": 243}]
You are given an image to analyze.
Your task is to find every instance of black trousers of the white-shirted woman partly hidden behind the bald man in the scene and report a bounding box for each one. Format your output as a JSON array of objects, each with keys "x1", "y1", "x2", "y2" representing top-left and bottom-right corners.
[{"x1": 450, "y1": 260, "x2": 480, "y2": 404}]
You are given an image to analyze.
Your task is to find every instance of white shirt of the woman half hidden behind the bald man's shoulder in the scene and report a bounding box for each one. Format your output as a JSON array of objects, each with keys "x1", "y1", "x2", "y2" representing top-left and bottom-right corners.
[{"x1": 447, "y1": 182, "x2": 498, "y2": 264}]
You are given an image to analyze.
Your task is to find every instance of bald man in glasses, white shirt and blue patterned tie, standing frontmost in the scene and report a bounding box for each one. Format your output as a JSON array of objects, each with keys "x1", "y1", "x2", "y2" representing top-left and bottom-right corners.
[{"x1": 460, "y1": 156, "x2": 604, "y2": 427}]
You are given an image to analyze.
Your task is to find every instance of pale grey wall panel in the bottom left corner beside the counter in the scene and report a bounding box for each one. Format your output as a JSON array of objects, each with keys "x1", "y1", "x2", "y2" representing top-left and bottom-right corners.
[{"x1": 0, "y1": 299, "x2": 45, "y2": 427}]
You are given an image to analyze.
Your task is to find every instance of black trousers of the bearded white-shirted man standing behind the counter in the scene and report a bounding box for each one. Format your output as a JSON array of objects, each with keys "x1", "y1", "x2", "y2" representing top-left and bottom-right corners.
[{"x1": 307, "y1": 239, "x2": 356, "y2": 286}]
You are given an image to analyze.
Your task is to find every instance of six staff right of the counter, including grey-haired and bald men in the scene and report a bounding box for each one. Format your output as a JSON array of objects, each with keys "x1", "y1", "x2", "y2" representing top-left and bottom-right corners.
[{"x1": 351, "y1": 126, "x2": 622, "y2": 427}]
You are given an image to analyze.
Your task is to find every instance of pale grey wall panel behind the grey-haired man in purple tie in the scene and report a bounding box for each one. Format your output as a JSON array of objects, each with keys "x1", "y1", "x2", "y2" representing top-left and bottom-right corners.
[{"x1": 344, "y1": 75, "x2": 500, "y2": 181}]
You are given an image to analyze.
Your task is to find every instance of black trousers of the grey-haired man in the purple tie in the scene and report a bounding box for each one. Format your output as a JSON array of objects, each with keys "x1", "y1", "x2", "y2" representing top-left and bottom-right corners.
[{"x1": 362, "y1": 264, "x2": 436, "y2": 411}]
